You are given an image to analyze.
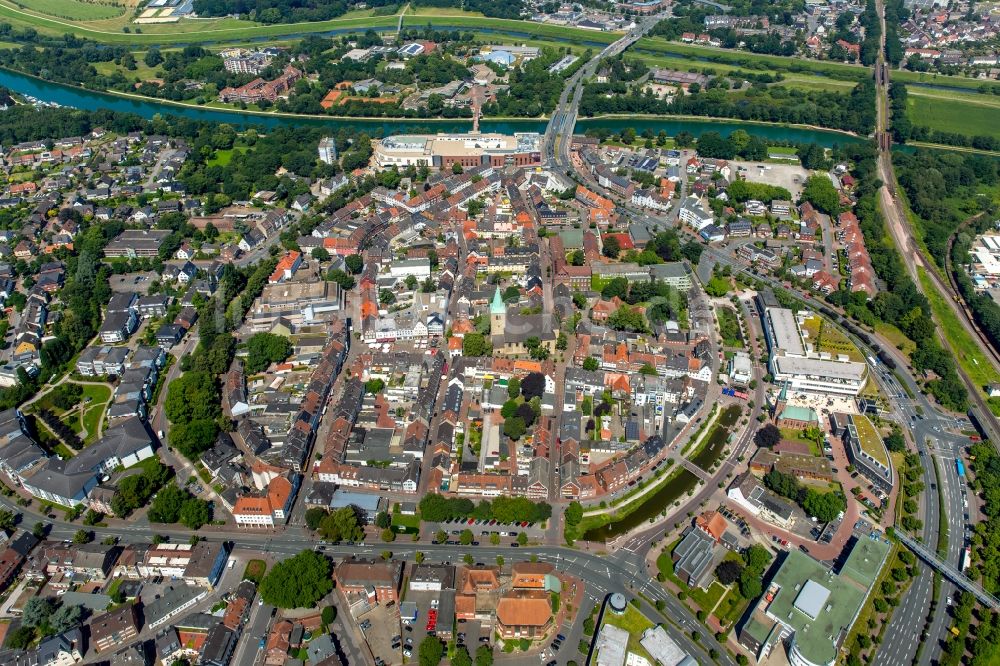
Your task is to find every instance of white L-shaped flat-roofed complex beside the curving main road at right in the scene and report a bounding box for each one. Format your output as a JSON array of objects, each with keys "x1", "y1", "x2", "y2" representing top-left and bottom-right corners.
[{"x1": 761, "y1": 307, "x2": 867, "y2": 396}]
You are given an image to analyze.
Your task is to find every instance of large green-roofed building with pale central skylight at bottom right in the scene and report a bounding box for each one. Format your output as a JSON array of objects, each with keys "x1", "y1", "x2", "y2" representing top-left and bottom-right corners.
[{"x1": 739, "y1": 538, "x2": 890, "y2": 666}]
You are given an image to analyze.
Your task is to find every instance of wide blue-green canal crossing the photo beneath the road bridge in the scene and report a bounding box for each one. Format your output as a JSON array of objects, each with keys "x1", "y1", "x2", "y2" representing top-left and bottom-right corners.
[{"x1": 0, "y1": 69, "x2": 859, "y2": 147}]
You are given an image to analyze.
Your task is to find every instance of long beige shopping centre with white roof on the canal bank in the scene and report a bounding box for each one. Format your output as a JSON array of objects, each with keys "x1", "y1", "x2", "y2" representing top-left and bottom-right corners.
[{"x1": 372, "y1": 132, "x2": 542, "y2": 169}]
